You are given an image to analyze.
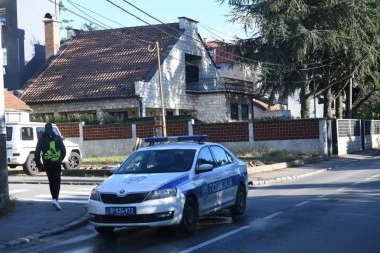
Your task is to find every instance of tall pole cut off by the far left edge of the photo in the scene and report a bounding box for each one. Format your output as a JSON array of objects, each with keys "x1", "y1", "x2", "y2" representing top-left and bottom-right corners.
[{"x1": 0, "y1": 21, "x2": 9, "y2": 208}]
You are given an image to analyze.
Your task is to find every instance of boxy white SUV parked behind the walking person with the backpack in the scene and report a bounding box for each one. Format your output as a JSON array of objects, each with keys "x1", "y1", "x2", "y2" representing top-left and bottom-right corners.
[{"x1": 6, "y1": 122, "x2": 82, "y2": 175}]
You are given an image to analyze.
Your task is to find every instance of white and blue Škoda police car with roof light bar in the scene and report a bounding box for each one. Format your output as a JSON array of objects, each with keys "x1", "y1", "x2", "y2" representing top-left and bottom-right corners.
[{"x1": 88, "y1": 135, "x2": 248, "y2": 234}]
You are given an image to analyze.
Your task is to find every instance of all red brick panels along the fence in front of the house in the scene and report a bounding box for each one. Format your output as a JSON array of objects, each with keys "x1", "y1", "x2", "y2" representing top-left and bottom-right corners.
[{"x1": 58, "y1": 119, "x2": 319, "y2": 142}]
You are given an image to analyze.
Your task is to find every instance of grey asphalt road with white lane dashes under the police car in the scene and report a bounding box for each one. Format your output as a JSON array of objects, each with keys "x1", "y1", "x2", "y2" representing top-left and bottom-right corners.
[{"x1": 5, "y1": 158, "x2": 380, "y2": 253}]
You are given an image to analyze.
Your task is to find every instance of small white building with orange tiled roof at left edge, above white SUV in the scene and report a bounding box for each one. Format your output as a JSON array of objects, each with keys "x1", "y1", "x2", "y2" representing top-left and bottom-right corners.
[{"x1": 4, "y1": 89, "x2": 32, "y2": 122}]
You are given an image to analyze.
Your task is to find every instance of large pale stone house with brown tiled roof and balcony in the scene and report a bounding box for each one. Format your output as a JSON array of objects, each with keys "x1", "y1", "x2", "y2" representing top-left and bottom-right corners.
[{"x1": 21, "y1": 17, "x2": 253, "y2": 122}]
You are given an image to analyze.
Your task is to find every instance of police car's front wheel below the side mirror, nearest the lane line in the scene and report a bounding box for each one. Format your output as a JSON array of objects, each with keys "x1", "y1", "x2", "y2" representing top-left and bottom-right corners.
[{"x1": 180, "y1": 197, "x2": 198, "y2": 233}]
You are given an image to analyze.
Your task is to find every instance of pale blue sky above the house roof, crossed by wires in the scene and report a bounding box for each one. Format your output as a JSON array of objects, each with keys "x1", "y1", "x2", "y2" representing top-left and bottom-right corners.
[{"x1": 56, "y1": 0, "x2": 248, "y2": 41}]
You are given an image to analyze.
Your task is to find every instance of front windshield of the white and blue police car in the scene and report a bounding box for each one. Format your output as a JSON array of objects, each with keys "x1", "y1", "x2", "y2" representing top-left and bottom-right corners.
[{"x1": 115, "y1": 149, "x2": 196, "y2": 174}]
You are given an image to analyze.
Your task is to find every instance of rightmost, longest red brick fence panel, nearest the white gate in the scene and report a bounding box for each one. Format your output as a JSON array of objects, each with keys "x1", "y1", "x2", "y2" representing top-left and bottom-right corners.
[{"x1": 253, "y1": 119, "x2": 319, "y2": 141}]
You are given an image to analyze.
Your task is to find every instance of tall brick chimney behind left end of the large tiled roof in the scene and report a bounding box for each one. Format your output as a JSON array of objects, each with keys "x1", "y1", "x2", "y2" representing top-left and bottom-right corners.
[{"x1": 44, "y1": 19, "x2": 60, "y2": 61}]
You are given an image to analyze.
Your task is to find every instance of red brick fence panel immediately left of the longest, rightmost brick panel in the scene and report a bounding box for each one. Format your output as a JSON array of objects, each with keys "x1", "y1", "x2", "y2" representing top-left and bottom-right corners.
[{"x1": 193, "y1": 123, "x2": 249, "y2": 142}]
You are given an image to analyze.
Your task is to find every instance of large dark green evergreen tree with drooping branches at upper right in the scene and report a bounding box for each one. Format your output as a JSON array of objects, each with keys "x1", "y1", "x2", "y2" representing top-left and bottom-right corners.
[{"x1": 218, "y1": 0, "x2": 380, "y2": 118}]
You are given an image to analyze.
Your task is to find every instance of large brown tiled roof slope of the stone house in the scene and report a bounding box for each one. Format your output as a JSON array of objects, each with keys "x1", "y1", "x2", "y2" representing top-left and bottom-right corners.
[{"x1": 22, "y1": 23, "x2": 181, "y2": 104}]
